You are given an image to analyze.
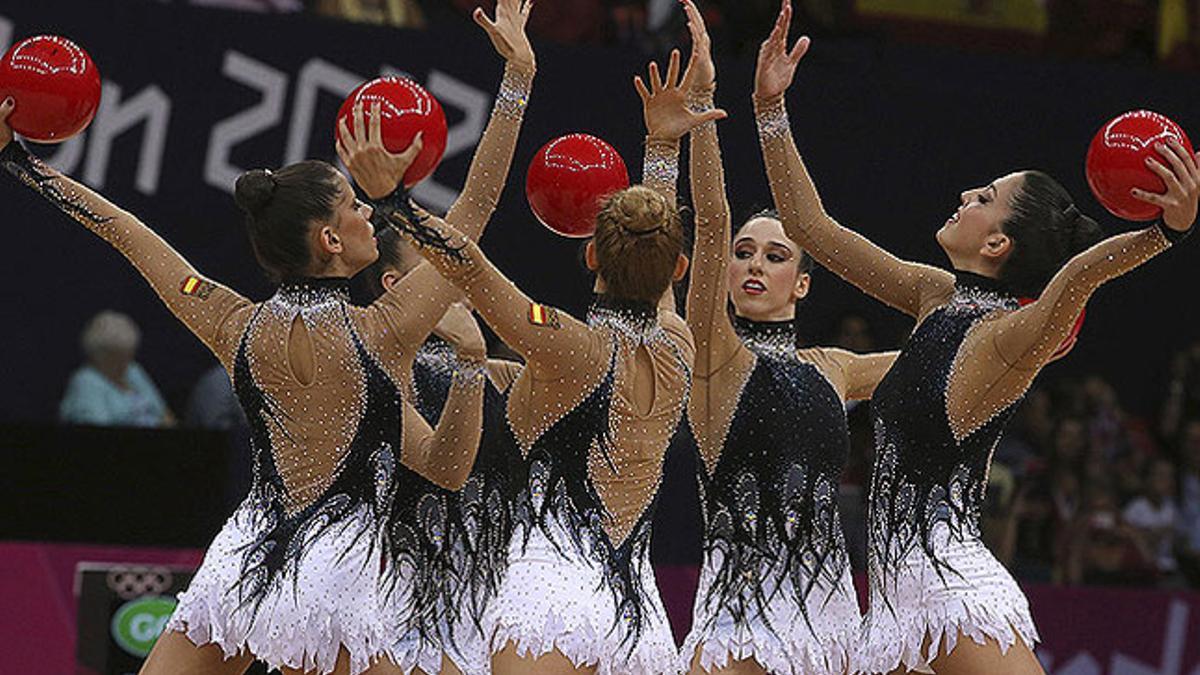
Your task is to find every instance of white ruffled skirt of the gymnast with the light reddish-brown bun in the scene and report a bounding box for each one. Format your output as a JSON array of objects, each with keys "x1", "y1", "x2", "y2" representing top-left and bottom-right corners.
[{"x1": 485, "y1": 511, "x2": 679, "y2": 675}]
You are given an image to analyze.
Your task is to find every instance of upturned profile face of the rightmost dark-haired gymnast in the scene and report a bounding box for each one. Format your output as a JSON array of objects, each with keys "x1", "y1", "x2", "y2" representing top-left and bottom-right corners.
[{"x1": 937, "y1": 173, "x2": 1025, "y2": 270}]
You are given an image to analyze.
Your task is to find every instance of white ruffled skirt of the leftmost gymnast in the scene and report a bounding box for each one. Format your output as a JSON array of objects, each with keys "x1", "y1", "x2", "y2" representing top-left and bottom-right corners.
[{"x1": 166, "y1": 502, "x2": 392, "y2": 675}]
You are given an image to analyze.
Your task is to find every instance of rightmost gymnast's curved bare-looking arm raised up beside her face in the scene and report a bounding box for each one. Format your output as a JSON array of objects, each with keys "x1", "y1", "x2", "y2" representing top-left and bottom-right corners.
[{"x1": 755, "y1": 0, "x2": 954, "y2": 316}]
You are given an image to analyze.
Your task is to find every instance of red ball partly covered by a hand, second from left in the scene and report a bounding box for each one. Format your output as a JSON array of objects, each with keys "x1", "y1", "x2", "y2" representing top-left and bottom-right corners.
[{"x1": 334, "y1": 77, "x2": 446, "y2": 186}]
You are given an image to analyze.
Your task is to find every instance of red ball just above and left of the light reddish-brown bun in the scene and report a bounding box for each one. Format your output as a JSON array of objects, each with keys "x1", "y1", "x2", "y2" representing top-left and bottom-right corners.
[{"x1": 526, "y1": 133, "x2": 629, "y2": 238}]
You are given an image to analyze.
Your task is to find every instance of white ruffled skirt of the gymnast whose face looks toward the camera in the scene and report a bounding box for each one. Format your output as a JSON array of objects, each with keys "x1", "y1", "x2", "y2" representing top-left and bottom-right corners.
[{"x1": 680, "y1": 550, "x2": 862, "y2": 675}]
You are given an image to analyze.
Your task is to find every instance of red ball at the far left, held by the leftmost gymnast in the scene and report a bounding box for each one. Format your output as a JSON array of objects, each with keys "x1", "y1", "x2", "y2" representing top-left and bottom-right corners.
[{"x1": 0, "y1": 35, "x2": 100, "y2": 143}]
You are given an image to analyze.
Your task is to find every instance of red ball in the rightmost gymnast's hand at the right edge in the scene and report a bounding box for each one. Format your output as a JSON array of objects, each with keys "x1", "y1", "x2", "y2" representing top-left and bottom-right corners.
[{"x1": 1086, "y1": 110, "x2": 1192, "y2": 220}]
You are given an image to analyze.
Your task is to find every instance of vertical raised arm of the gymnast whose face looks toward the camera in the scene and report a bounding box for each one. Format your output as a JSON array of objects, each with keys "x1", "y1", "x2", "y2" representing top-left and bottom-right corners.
[{"x1": 684, "y1": 0, "x2": 742, "y2": 378}]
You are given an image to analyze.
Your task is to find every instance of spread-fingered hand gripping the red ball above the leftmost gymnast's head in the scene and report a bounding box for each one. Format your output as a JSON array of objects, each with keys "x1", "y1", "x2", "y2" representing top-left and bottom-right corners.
[{"x1": 337, "y1": 101, "x2": 424, "y2": 199}]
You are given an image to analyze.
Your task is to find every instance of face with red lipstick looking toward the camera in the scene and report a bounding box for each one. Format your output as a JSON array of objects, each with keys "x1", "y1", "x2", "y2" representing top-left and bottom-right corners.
[{"x1": 728, "y1": 217, "x2": 809, "y2": 321}]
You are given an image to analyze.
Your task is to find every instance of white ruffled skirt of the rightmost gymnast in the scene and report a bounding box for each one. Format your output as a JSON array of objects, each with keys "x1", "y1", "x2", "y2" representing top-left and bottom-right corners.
[{"x1": 854, "y1": 524, "x2": 1038, "y2": 673}]
